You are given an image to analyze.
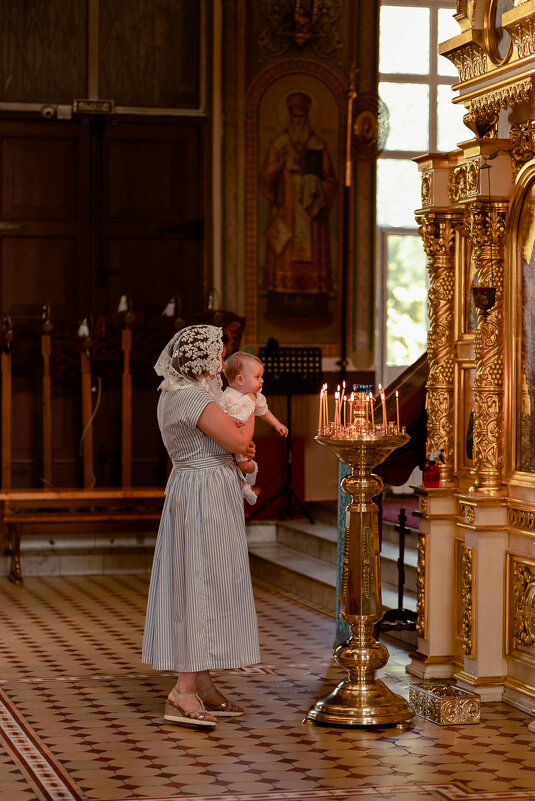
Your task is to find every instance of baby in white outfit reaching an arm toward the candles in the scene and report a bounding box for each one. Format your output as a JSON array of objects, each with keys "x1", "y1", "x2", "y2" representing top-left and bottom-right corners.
[{"x1": 220, "y1": 351, "x2": 288, "y2": 505}]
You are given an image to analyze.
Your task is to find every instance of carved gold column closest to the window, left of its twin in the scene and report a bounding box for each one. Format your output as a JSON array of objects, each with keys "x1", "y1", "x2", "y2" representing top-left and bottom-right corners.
[{"x1": 417, "y1": 209, "x2": 464, "y2": 486}]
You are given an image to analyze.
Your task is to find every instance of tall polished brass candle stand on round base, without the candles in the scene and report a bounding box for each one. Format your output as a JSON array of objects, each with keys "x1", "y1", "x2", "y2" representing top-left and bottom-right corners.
[{"x1": 307, "y1": 434, "x2": 414, "y2": 726}]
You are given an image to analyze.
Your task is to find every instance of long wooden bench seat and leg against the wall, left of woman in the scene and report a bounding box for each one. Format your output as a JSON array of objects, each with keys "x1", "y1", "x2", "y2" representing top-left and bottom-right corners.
[{"x1": 0, "y1": 487, "x2": 165, "y2": 584}]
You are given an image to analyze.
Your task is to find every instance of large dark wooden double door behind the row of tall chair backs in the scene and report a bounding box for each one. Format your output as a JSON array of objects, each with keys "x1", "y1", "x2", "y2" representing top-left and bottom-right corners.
[{"x1": 0, "y1": 118, "x2": 206, "y2": 486}]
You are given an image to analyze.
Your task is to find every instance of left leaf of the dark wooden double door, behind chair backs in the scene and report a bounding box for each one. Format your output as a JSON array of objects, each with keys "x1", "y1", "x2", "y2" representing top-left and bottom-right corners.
[{"x1": 0, "y1": 120, "x2": 91, "y2": 486}]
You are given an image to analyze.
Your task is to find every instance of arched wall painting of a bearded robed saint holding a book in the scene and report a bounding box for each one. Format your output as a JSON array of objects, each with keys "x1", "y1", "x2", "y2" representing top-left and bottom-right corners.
[{"x1": 246, "y1": 61, "x2": 346, "y2": 356}]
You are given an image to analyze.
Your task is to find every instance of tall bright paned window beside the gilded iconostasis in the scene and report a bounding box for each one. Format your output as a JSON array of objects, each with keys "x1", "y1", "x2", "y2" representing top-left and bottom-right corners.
[{"x1": 377, "y1": 0, "x2": 464, "y2": 385}]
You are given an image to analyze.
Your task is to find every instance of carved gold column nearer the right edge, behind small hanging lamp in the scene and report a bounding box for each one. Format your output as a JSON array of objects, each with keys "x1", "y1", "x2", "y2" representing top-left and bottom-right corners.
[{"x1": 467, "y1": 200, "x2": 508, "y2": 495}]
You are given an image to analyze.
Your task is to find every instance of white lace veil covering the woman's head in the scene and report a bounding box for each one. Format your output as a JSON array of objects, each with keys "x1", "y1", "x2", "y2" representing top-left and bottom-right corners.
[{"x1": 154, "y1": 325, "x2": 223, "y2": 400}]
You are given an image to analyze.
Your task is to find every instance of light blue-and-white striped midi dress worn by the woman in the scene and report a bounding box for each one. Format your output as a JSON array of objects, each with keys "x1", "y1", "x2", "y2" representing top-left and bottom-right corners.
[{"x1": 142, "y1": 385, "x2": 260, "y2": 673}]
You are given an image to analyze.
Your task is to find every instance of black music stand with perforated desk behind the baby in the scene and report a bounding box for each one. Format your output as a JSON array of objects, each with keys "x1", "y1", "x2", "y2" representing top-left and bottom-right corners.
[{"x1": 247, "y1": 346, "x2": 323, "y2": 523}]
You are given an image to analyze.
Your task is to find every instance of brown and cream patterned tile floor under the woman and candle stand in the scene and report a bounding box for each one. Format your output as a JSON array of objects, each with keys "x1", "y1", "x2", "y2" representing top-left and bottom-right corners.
[{"x1": 0, "y1": 575, "x2": 535, "y2": 801}]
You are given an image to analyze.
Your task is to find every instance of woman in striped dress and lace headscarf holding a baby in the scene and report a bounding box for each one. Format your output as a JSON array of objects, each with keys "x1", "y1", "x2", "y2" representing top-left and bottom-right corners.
[{"x1": 142, "y1": 325, "x2": 260, "y2": 729}]
